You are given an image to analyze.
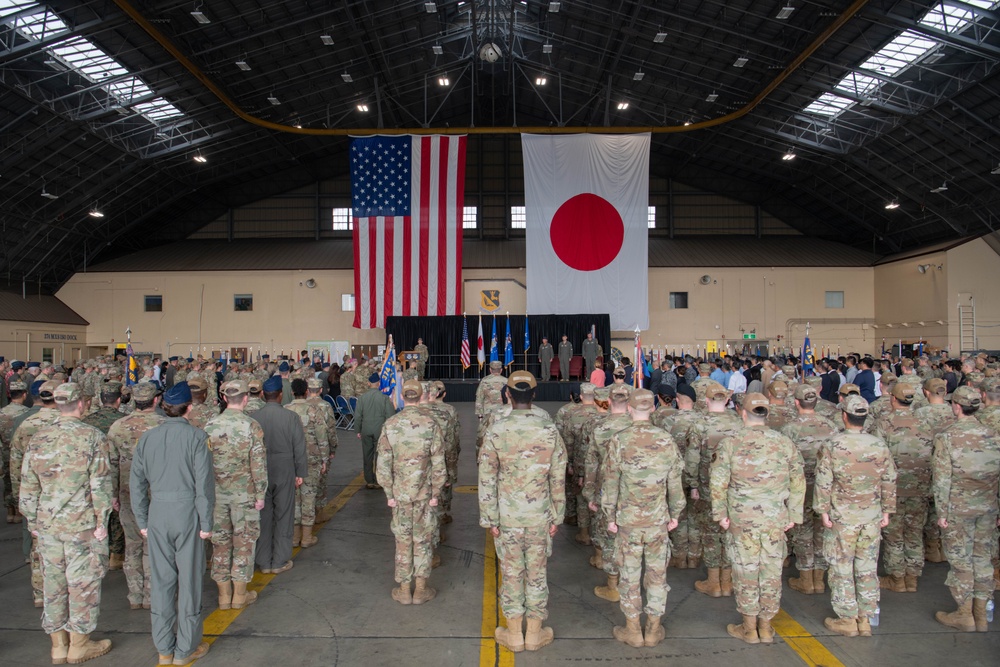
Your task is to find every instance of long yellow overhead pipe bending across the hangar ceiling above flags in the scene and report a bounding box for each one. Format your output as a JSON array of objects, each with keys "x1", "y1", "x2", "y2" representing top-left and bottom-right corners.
[{"x1": 114, "y1": 0, "x2": 868, "y2": 136}]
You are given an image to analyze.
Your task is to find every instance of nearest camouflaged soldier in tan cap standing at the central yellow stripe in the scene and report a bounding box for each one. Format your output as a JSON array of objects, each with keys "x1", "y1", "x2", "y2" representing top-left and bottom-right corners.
[{"x1": 479, "y1": 371, "x2": 567, "y2": 652}]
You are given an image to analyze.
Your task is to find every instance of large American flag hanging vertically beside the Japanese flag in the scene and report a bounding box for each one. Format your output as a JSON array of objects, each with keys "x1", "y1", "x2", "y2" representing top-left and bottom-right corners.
[{"x1": 350, "y1": 135, "x2": 466, "y2": 329}]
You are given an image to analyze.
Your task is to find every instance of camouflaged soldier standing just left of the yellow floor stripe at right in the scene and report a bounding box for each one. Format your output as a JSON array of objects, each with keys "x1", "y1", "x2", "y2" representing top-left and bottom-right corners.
[{"x1": 710, "y1": 394, "x2": 806, "y2": 644}]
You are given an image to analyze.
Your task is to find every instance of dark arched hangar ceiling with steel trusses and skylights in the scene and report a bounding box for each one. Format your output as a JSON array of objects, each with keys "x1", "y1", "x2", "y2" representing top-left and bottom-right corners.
[{"x1": 0, "y1": 0, "x2": 1000, "y2": 289}]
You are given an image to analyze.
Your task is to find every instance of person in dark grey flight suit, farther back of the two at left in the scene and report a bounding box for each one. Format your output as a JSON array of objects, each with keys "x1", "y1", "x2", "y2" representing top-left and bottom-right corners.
[{"x1": 251, "y1": 375, "x2": 307, "y2": 574}]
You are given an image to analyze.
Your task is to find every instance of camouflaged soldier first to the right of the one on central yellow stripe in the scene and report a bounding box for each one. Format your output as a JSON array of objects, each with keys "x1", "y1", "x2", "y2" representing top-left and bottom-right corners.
[{"x1": 601, "y1": 389, "x2": 687, "y2": 648}]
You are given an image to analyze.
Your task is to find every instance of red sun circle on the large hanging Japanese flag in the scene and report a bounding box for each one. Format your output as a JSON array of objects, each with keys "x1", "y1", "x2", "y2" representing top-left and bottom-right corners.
[{"x1": 549, "y1": 192, "x2": 625, "y2": 271}]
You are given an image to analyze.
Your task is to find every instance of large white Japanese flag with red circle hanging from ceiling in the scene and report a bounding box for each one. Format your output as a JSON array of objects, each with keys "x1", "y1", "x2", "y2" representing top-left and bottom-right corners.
[{"x1": 521, "y1": 133, "x2": 650, "y2": 331}]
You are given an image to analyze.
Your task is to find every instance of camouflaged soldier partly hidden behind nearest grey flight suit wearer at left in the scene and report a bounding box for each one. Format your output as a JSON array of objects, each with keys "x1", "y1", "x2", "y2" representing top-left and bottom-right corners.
[{"x1": 108, "y1": 382, "x2": 166, "y2": 610}]
